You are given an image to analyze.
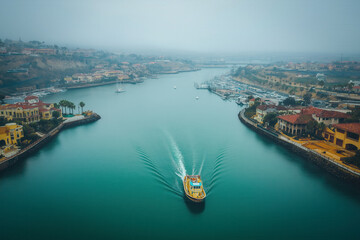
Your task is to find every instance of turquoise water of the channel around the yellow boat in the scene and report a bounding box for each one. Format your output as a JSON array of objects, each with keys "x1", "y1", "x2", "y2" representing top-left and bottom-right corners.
[{"x1": 0, "y1": 69, "x2": 360, "y2": 239}]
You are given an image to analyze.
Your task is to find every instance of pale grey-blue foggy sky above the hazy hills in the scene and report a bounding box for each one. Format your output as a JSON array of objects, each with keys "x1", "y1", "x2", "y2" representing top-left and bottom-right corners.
[{"x1": 0, "y1": 0, "x2": 360, "y2": 53}]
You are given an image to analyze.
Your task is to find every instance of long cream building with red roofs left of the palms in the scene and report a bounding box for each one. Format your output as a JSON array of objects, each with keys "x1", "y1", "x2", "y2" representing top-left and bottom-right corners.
[{"x1": 0, "y1": 96, "x2": 62, "y2": 124}]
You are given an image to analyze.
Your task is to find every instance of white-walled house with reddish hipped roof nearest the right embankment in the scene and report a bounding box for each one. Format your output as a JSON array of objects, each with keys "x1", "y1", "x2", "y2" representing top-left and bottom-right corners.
[{"x1": 277, "y1": 113, "x2": 314, "y2": 135}]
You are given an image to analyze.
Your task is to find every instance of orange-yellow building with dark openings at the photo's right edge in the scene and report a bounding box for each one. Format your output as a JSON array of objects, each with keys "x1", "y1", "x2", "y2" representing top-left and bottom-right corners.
[{"x1": 324, "y1": 123, "x2": 360, "y2": 150}]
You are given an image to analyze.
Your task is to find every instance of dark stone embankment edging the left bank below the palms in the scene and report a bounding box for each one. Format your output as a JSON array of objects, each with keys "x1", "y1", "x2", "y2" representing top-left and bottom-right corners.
[{"x1": 0, "y1": 113, "x2": 101, "y2": 172}]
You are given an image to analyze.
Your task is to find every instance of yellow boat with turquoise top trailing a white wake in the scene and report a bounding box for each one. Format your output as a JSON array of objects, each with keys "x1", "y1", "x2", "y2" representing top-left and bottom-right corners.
[{"x1": 184, "y1": 175, "x2": 206, "y2": 202}]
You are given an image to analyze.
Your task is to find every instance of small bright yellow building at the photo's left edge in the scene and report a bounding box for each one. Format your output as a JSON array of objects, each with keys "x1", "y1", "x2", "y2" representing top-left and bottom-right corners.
[{"x1": 0, "y1": 123, "x2": 24, "y2": 147}]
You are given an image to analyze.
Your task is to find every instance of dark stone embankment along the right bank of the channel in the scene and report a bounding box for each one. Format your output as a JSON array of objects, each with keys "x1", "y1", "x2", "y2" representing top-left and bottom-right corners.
[{"x1": 238, "y1": 109, "x2": 360, "y2": 185}]
